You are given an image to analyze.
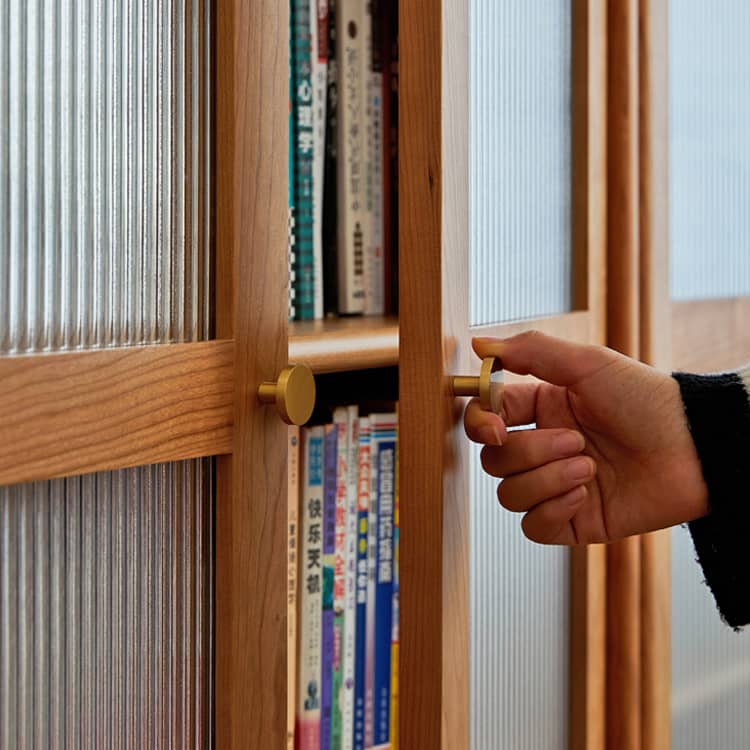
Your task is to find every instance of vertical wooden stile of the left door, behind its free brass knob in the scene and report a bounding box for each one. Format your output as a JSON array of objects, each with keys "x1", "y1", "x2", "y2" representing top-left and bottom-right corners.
[{"x1": 214, "y1": 0, "x2": 289, "y2": 750}]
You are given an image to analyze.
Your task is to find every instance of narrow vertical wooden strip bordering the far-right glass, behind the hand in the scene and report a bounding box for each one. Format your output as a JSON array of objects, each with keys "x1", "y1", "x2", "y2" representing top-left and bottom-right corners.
[{"x1": 638, "y1": 0, "x2": 672, "y2": 750}]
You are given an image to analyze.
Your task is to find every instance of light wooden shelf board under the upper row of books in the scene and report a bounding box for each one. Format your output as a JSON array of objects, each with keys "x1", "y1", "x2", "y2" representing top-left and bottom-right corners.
[{"x1": 289, "y1": 317, "x2": 398, "y2": 373}]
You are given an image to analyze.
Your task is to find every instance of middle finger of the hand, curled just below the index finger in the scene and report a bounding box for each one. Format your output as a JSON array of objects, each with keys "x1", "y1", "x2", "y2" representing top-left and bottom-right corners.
[{"x1": 482, "y1": 429, "x2": 586, "y2": 477}]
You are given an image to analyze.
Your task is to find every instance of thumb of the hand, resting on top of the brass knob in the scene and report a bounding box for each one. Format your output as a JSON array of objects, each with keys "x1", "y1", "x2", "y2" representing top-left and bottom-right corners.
[{"x1": 472, "y1": 331, "x2": 617, "y2": 386}]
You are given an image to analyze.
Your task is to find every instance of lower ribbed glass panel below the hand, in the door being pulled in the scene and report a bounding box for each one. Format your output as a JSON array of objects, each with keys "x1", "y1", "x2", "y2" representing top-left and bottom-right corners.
[{"x1": 470, "y1": 446, "x2": 570, "y2": 750}]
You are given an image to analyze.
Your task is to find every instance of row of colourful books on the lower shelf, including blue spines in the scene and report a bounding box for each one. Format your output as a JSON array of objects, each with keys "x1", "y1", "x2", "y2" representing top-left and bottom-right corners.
[{"x1": 288, "y1": 406, "x2": 399, "y2": 750}]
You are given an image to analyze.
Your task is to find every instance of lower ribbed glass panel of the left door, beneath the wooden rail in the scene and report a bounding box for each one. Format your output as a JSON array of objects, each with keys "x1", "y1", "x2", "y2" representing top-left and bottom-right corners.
[{"x1": 0, "y1": 459, "x2": 213, "y2": 748}]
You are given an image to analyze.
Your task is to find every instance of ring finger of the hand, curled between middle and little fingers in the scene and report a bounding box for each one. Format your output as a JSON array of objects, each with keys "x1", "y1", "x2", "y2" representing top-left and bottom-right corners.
[{"x1": 497, "y1": 456, "x2": 596, "y2": 512}]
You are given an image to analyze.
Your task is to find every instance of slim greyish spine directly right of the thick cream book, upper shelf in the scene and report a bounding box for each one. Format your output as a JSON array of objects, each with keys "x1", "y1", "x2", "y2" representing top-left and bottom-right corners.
[{"x1": 364, "y1": 0, "x2": 385, "y2": 315}]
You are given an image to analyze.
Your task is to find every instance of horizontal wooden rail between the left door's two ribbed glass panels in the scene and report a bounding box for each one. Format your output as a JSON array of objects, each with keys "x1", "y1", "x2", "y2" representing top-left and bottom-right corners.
[{"x1": 0, "y1": 341, "x2": 234, "y2": 484}]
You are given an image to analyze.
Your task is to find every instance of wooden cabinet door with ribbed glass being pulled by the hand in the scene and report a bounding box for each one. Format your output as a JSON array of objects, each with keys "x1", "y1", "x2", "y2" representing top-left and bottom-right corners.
[{"x1": 399, "y1": 0, "x2": 606, "y2": 750}]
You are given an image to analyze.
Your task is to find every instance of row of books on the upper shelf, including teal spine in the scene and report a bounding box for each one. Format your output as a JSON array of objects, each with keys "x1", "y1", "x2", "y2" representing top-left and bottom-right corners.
[{"x1": 289, "y1": 0, "x2": 398, "y2": 320}]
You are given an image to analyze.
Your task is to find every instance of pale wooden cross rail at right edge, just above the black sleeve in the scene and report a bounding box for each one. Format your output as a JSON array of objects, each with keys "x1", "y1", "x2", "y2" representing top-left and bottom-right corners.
[{"x1": 672, "y1": 297, "x2": 750, "y2": 372}]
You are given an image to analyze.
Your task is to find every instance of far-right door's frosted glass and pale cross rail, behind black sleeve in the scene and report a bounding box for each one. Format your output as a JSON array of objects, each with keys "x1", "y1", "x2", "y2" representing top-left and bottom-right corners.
[{"x1": 669, "y1": 0, "x2": 750, "y2": 750}]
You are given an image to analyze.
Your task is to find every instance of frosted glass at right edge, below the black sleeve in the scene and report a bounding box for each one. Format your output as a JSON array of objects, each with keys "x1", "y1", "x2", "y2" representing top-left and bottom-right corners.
[{"x1": 672, "y1": 528, "x2": 750, "y2": 750}]
